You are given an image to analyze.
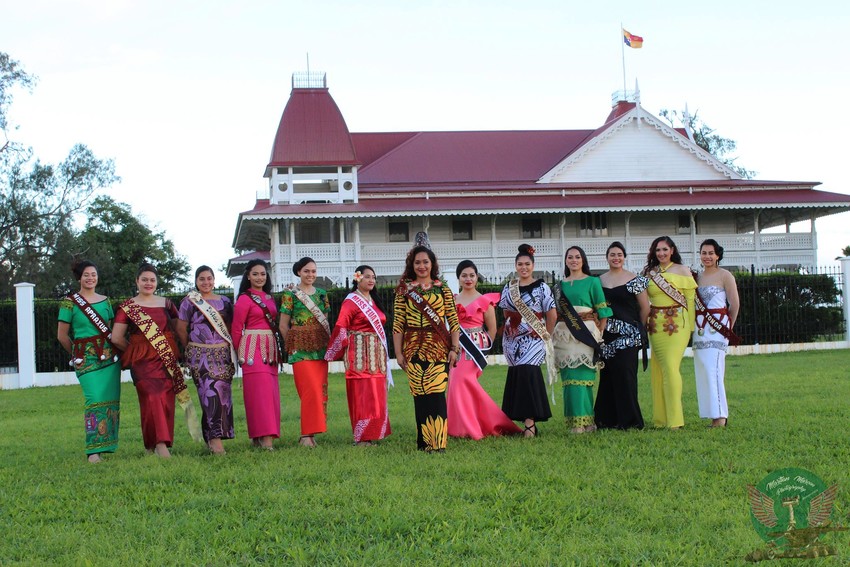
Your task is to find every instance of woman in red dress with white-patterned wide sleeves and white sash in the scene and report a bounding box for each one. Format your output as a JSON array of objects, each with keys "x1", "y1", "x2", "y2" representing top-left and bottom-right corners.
[{"x1": 325, "y1": 265, "x2": 392, "y2": 447}]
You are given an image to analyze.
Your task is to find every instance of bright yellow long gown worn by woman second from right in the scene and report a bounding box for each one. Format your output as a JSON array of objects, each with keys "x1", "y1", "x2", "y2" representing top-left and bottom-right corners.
[{"x1": 647, "y1": 272, "x2": 697, "y2": 427}]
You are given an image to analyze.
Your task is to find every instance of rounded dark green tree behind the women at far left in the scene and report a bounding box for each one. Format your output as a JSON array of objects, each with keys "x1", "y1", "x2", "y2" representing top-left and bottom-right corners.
[{"x1": 54, "y1": 196, "x2": 191, "y2": 297}]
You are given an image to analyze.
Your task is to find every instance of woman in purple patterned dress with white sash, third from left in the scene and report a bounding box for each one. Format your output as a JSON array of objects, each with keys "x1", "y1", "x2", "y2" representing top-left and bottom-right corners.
[{"x1": 177, "y1": 266, "x2": 235, "y2": 455}]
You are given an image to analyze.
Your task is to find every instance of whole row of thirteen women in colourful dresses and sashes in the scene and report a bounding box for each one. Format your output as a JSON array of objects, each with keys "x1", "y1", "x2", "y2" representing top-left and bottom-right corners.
[{"x1": 58, "y1": 237, "x2": 738, "y2": 462}]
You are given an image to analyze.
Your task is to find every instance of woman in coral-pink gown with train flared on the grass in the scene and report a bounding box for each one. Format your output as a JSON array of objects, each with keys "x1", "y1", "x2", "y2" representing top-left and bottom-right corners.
[{"x1": 447, "y1": 260, "x2": 521, "y2": 440}]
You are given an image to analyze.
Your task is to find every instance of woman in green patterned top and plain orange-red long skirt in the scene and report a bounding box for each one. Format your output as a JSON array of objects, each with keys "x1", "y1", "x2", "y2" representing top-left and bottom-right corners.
[{"x1": 280, "y1": 257, "x2": 330, "y2": 447}]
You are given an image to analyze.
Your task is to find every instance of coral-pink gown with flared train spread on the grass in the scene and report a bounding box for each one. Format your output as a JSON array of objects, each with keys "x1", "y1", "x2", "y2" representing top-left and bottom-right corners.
[{"x1": 446, "y1": 293, "x2": 521, "y2": 440}]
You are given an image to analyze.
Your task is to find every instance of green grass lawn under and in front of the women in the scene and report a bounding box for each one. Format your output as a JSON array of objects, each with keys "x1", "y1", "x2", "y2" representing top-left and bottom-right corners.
[{"x1": 0, "y1": 351, "x2": 850, "y2": 565}]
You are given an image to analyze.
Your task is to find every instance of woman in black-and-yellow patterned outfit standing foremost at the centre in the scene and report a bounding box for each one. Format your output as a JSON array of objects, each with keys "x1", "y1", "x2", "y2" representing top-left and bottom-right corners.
[{"x1": 393, "y1": 245, "x2": 460, "y2": 453}]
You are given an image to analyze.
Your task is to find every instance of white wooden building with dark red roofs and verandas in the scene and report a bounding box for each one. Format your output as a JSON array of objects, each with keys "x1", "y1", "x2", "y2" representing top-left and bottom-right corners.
[{"x1": 228, "y1": 75, "x2": 850, "y2": 288}]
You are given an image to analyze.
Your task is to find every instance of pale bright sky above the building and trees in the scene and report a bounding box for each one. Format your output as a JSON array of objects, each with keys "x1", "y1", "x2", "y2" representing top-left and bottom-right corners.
[{"x1": 0, "y1": 0, "x2": 850, "y2": 280}]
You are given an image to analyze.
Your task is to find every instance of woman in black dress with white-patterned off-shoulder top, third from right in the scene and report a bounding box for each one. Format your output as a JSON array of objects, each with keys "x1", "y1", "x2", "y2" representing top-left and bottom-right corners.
[{"x1": 593, "y1": 242, "x2": 649, "y2": 429}]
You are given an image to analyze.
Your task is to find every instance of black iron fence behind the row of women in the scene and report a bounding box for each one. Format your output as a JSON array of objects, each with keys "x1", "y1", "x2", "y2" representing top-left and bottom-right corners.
[{"x1": 0, "y1": 268, "x2": 846, "y2": 372}]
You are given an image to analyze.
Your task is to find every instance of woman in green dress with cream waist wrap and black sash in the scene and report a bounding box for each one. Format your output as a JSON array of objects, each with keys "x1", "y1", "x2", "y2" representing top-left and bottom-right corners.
[{"x1": 553, "y1": 246, "x2": 613, "y2": 433}]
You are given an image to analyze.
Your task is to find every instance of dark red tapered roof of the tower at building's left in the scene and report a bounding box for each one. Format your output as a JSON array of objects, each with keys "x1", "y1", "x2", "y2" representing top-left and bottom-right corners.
[{"x1": 268, "y1": 89, "x2": 358, "y2": 167}]
